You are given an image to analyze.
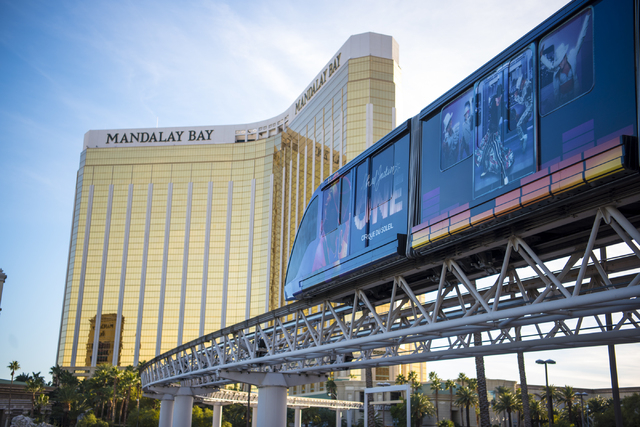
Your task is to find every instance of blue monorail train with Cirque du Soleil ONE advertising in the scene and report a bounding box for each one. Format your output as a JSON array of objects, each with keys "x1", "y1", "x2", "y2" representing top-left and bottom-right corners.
[{"x1": 284, "y1": 0, "x2": 640, "y2": 300}]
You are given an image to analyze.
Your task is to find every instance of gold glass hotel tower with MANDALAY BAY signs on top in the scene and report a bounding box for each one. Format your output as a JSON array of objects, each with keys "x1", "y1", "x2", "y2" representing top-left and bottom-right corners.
[{"x1": 57, "y1": 33, "x2": 400, "y2": 375}]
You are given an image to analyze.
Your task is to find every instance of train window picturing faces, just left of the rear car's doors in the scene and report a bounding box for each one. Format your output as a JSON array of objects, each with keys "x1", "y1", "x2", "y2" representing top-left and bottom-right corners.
[{"x1": 440, "y1": 88, "x2": 475, "y2": 170}]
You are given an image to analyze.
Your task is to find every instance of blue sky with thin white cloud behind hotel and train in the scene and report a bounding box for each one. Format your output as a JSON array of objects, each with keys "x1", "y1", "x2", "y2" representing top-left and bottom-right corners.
[{"x1": 0, "y1": 0, "x2": 640, "y2": 387}]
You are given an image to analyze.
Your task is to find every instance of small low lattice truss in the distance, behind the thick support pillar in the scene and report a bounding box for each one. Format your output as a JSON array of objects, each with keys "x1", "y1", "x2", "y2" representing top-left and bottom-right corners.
[{"x1": 198, "y1": 389, "x2": 363, "y2": 409}]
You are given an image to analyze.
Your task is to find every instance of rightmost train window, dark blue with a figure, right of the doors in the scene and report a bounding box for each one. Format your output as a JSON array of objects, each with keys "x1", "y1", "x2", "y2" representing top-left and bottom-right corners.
[{"x1": 540, "y1": 8, "x2": 594, "y2": 115}]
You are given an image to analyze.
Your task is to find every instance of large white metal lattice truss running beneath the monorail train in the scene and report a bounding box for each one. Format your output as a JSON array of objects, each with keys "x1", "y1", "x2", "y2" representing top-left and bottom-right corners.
[{"x1": 142, "y1": 207, "x2": 640, "y2": 387}]
